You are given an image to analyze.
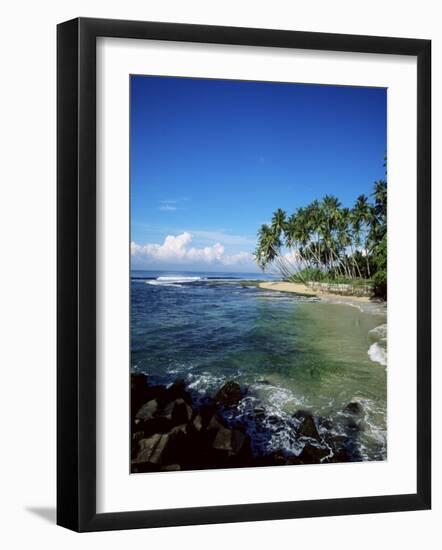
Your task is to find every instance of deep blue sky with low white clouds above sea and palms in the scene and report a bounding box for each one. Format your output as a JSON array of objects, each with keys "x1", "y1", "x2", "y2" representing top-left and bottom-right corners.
[{"x1": 130, "y1": 76, "x2": 387, "y2": 271}]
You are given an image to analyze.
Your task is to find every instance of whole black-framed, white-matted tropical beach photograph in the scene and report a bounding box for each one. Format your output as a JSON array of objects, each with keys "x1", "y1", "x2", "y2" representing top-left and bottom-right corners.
[{"x1": 57, "y1": 18, "x2": 431, "y2": 531}]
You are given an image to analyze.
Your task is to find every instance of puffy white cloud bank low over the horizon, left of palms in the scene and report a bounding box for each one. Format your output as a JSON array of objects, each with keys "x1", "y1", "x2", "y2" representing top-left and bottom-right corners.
[{"x1": 131, "y1": 231, "x2": 254, "y2": 267}]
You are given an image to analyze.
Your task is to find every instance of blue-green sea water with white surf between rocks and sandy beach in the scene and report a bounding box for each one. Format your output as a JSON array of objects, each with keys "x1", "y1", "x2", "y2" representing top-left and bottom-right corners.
[{"x1": 131, "y1": 271, "x2": 387, "y2": 460}]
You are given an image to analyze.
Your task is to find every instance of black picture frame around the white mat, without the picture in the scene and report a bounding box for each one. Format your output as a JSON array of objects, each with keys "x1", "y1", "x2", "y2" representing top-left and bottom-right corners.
[{"x1": 57, "y1": 18, "x2": 431, "y2": 531}]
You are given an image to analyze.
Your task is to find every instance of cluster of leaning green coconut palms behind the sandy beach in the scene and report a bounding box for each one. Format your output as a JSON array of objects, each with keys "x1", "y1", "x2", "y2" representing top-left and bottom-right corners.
[{"x1": 255, "y1": 163, "x2": 387, "y2": 298}]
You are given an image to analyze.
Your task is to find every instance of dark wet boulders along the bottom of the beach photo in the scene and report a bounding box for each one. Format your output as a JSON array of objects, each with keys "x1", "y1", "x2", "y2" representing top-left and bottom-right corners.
[{"x1": 131, "y1": 373, "x2": 362, "y2": 473}]
